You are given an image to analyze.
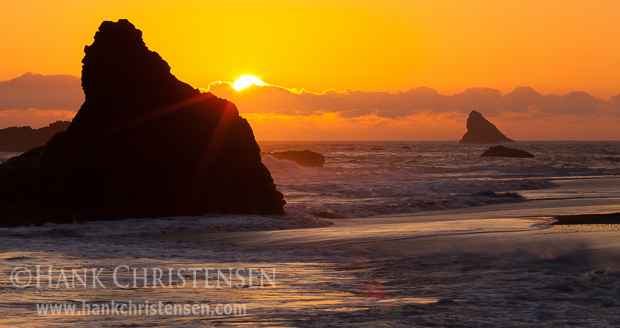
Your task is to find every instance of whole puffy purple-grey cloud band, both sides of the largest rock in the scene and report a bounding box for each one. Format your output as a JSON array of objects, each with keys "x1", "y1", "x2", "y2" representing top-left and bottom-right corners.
[{"x1": 6, "y1": 73, "x2": 604, "y2": 119}]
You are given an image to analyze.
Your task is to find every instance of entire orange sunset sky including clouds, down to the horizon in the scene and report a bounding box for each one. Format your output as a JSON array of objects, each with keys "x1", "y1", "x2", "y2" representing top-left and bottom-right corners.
[{"x1": 0, "y1": 0, "x2": 620, "y2": 140}]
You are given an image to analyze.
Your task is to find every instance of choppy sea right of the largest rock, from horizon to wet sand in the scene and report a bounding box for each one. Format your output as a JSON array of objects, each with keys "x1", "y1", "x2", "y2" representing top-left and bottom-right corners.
[{"x1": 260, "y1": 141, "x2": 620, "y2": 218}]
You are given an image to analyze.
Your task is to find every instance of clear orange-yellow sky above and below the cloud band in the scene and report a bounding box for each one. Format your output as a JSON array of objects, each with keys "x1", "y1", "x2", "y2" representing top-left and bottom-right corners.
[{"x1": 0, "y1": 0, "x2": 620, "y2": 140}]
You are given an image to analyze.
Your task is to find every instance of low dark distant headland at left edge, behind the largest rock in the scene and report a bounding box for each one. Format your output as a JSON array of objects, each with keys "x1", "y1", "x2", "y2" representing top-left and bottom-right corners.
[{"x1": 0, "y1": 121, "x2": 71, "y2": 152}]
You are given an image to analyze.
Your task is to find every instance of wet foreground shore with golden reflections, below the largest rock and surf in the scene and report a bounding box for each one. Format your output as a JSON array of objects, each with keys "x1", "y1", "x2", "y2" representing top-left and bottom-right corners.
[{"x1": 0, "y1": 177, "x2": 620, "y2": 327}]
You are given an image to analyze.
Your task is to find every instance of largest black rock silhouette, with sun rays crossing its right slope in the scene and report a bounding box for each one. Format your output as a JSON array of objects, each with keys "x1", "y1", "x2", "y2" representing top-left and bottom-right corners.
[{"x1": 0, "y1": 20, "x2": 285, "y2": 226}]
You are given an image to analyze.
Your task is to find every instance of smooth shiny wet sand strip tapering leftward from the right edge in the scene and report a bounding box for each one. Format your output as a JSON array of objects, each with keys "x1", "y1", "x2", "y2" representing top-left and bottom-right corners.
[{"x1": 155, "y1": 178, "x2": 620, "y2": 266}]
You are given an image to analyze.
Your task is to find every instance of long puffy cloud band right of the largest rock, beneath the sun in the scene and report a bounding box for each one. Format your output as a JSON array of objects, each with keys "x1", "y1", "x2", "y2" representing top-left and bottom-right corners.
[{"x1": 208, "y1": 82, "x2": 620, "y2": 119}]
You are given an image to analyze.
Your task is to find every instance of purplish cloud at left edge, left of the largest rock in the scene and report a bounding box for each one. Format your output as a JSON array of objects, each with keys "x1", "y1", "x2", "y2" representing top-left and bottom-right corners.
[{"x1": 0, "y1": 73, "x2": 84, "y2": 111}]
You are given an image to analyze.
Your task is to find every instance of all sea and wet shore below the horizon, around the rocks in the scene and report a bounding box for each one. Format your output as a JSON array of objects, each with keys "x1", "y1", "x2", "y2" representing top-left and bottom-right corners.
[{"x1": 0, "y1": 141, "x2": 620, "y2": 327}]
